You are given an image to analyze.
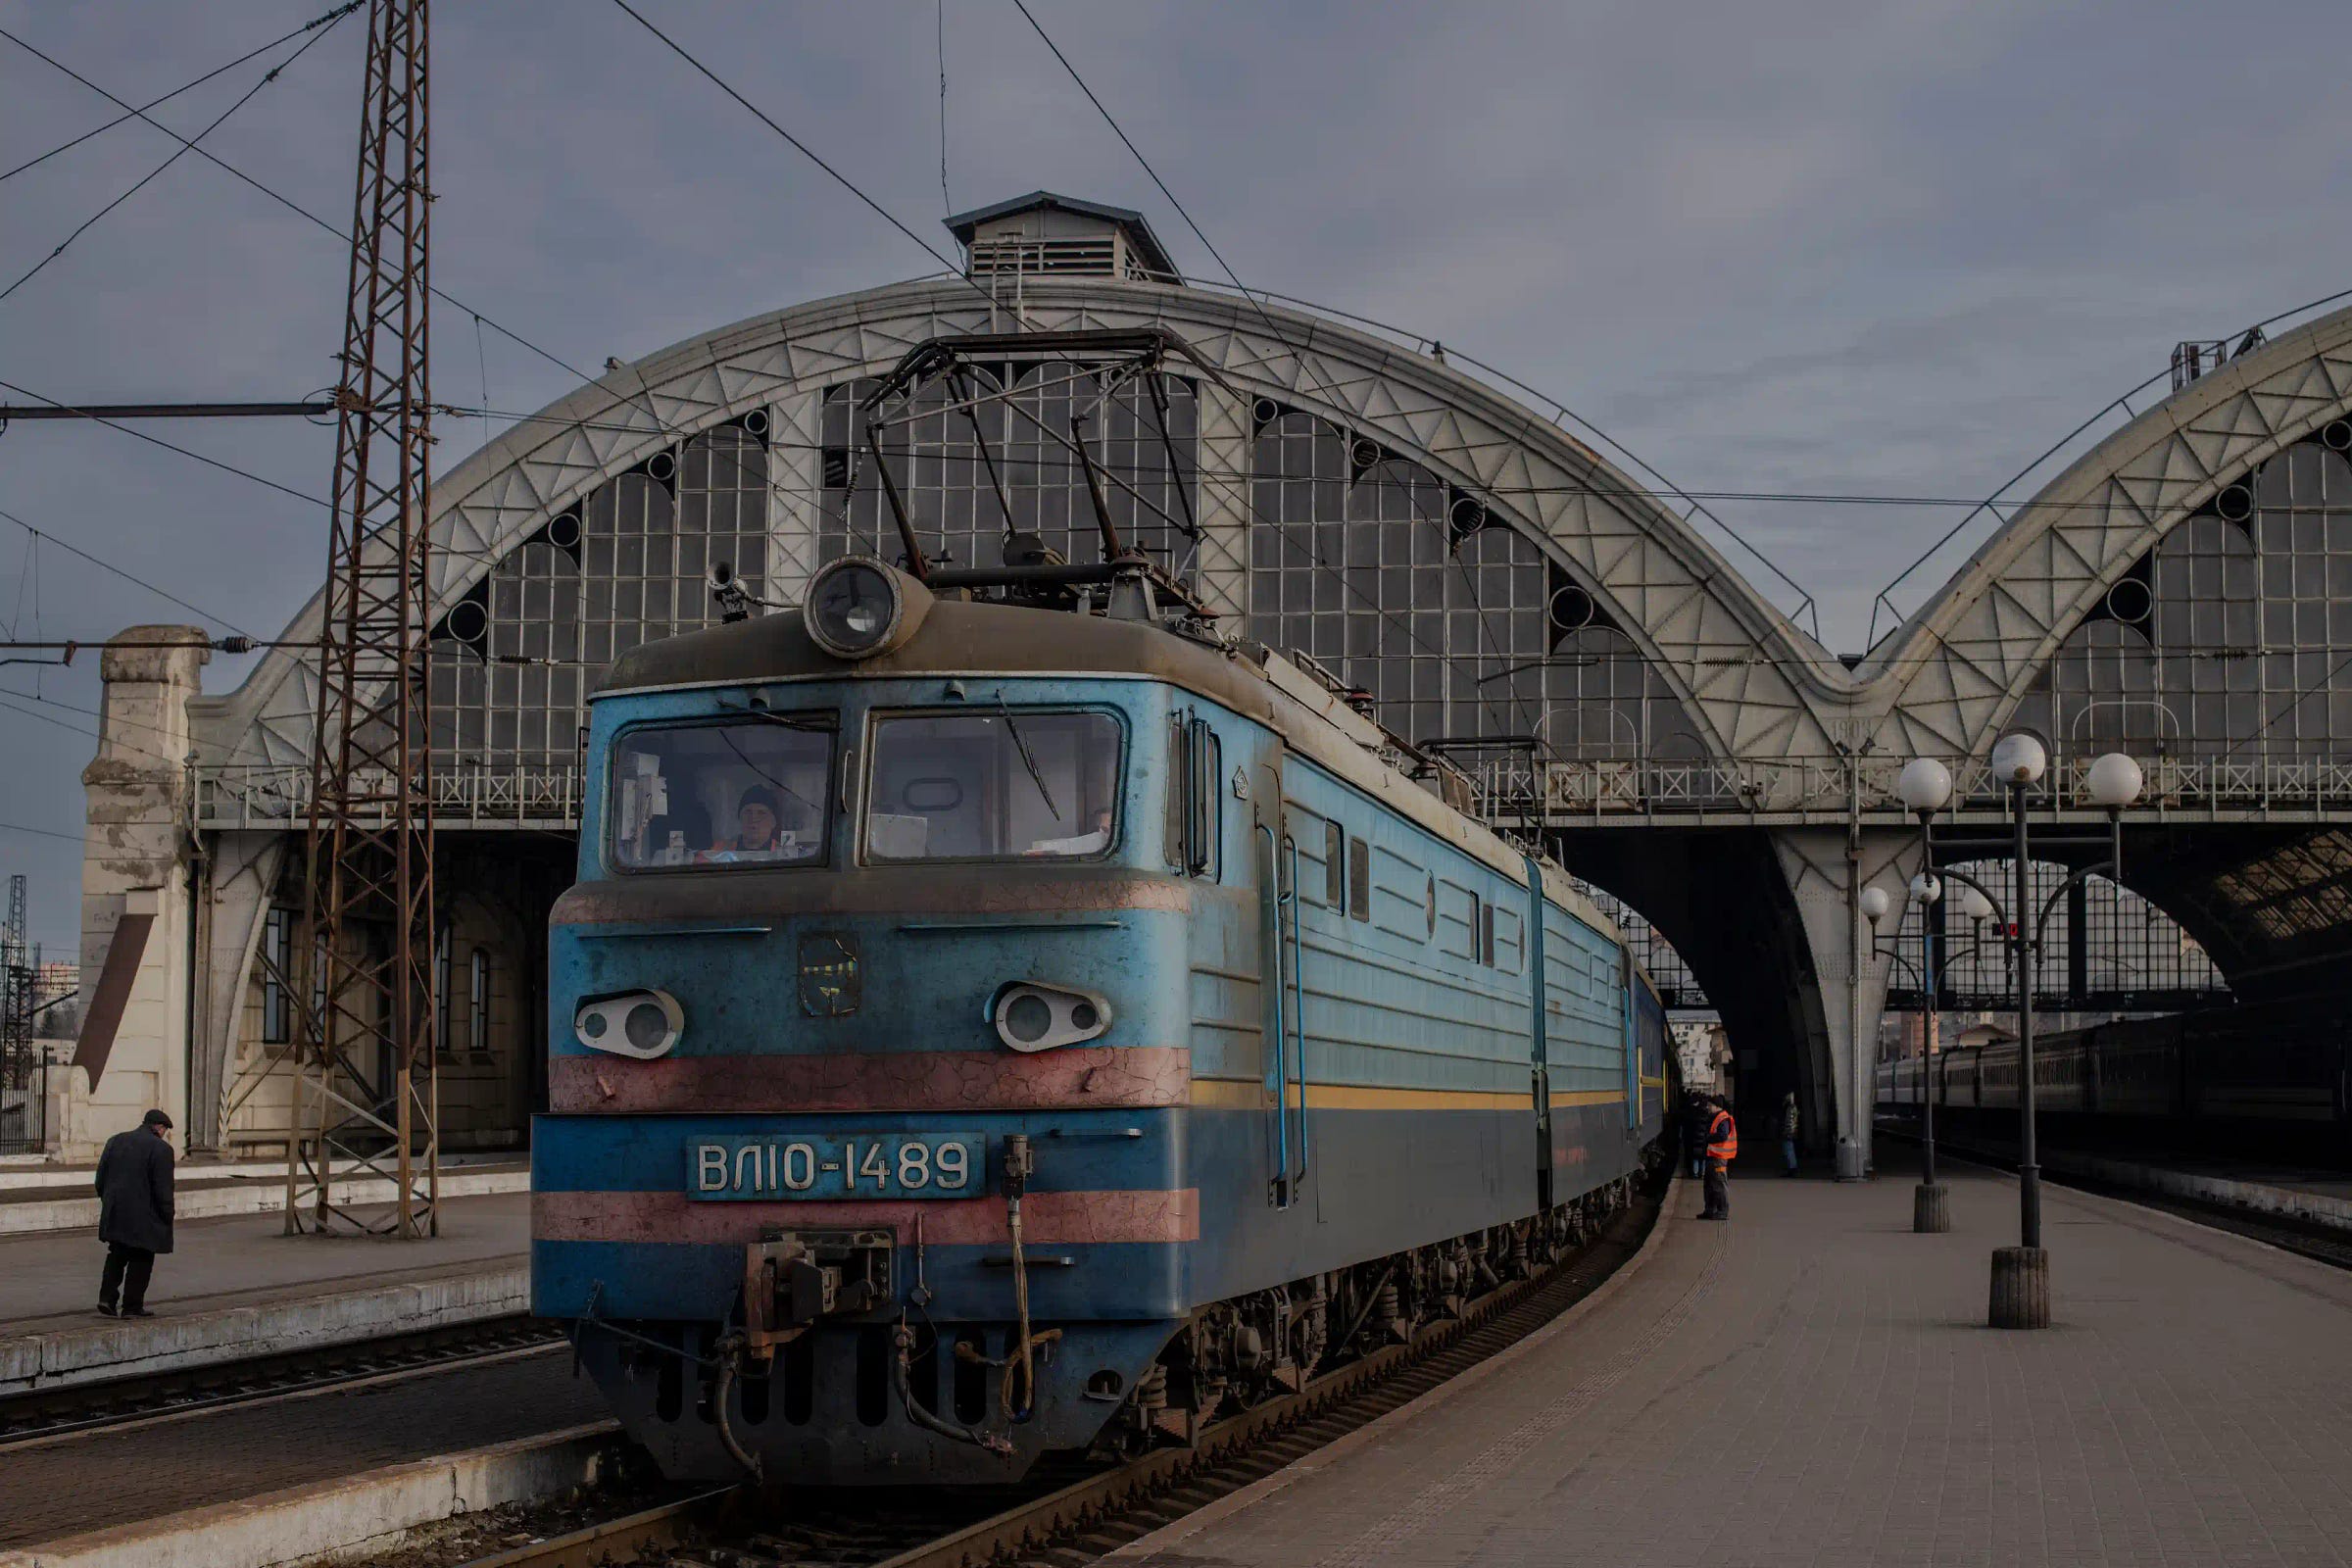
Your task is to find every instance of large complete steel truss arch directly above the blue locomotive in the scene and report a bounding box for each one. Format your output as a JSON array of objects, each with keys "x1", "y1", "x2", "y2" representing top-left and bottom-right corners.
[{"x1": 198, "y1": 279, "x2": 1848, "y2": 780}]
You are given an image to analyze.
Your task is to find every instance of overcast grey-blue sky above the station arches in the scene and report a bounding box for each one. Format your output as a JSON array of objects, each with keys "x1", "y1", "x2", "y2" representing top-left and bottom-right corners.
[{"x1": 0, "y1": 0, "x2": 2352, "y2": 950}]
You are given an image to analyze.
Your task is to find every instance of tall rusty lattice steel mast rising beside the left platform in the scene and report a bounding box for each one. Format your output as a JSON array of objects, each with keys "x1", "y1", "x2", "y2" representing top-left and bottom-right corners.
[{"x1": 287, "y1": 0, "x2": 440, "y2": 1237}]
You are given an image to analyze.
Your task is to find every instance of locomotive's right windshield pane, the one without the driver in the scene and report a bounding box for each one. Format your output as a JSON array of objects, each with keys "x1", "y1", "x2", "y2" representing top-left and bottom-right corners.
[{"x1": 865, "y1": 708, "x2": 1119, "y2": 860}]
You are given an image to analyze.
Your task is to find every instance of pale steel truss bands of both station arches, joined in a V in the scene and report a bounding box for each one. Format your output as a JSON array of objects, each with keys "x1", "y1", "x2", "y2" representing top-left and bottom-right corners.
[{"x1": 198, "y1": 266, "x2": 2352, "y2": 808}]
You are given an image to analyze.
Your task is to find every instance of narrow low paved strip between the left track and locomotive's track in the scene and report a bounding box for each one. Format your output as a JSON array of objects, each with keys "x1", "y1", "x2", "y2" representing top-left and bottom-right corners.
[{"x1": 0, "y1": 1348, "x2": 610, "y2": 1549}]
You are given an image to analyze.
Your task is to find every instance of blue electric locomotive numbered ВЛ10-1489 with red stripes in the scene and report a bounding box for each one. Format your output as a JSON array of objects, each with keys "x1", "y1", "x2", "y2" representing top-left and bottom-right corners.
[{"x1": 531, "y1": 546, "x2": 1672, "y2": 1486}]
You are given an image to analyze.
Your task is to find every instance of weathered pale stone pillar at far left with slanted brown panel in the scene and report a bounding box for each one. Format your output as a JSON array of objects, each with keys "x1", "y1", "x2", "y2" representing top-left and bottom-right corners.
[{"x1": 59, "y1": 625, "x2": 212, "y2": 1156}]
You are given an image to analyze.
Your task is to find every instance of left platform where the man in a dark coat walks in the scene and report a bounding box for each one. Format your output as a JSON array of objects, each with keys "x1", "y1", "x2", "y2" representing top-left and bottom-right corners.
[{"x1": 0, "y1": 1192, "x2": 531, "y2": 1394}]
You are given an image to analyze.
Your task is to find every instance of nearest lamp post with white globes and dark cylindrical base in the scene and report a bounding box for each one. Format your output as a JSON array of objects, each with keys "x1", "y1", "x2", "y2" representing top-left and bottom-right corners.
[{"x1": 1922, "y1": 733, "x2": 2142, "y2": 1328}]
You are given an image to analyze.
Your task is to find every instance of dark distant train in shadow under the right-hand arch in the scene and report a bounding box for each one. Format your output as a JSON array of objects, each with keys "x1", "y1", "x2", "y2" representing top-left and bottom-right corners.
[{"x1": 1877, "y1": 997, "x2": 2352, "y2": 1163}]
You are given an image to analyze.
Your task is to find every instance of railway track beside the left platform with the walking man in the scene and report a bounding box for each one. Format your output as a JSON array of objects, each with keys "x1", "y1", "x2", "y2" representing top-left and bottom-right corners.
[{"x1": 0, "y1": 1312, "x2": 564, "y2": 1452}]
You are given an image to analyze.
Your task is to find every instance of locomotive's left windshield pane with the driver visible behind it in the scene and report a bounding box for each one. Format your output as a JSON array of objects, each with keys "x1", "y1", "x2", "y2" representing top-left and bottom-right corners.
[{"x1": 610, "y1": 712, "x2": 837, "y2": 870}]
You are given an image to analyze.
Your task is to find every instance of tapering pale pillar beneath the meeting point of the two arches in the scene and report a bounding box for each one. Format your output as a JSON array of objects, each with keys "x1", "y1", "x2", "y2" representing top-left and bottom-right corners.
[{"x1": 1771, "y1": 827, "x2": 1919, "y2": 1180}]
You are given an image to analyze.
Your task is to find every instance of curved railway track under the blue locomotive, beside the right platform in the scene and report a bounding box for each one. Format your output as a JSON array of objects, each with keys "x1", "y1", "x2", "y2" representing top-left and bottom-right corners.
[{"x1": 437, "y1": 1187, "x2": 1670, "y2": 1568}]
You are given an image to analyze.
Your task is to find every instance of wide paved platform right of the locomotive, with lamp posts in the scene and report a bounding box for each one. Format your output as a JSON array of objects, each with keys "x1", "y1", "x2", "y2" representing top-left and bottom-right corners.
[{"x1": 1115, "y1": 1140, "x2": 2352, "y2": 1568}]
